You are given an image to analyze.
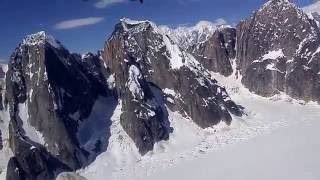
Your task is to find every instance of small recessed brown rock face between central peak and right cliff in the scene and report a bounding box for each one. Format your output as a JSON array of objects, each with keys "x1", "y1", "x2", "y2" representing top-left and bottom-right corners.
[{"x1": 188, "y1": 27, "x2": 236, "y2": 76}]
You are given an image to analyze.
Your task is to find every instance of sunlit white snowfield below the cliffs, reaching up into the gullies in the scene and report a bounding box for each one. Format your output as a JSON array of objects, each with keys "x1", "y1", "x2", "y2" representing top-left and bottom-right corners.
[{"x1": 78, "y1": 70, "x2": 320, "y2": 180}]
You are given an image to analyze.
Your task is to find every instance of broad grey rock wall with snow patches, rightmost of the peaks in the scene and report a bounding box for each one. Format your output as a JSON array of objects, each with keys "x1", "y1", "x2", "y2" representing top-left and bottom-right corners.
[{"x1": 237, "y1": 0, "x2": 320, "y2": 101}]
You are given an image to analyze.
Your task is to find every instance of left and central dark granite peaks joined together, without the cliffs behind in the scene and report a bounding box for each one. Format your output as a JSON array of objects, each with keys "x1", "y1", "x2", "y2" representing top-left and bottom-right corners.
[{"x1": 2, "y1": 19, "x2": 242, "y2": 180}]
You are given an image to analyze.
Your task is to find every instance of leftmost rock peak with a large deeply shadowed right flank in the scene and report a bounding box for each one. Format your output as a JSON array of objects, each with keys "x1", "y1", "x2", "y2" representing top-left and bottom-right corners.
[{"x1": 6, "y1": 32, "x2": 116, "y2": 179}]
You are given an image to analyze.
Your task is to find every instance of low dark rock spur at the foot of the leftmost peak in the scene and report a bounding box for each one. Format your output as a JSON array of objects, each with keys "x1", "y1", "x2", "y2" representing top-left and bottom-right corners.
[{"x1": 7, "y1": 121, "x2": 71, "y2": 180}]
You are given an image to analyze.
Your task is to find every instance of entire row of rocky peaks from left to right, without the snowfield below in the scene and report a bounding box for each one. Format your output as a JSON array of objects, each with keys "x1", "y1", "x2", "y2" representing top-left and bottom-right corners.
[{"x1": 0, "y1": 0, "x2": 320, "y2": 180}]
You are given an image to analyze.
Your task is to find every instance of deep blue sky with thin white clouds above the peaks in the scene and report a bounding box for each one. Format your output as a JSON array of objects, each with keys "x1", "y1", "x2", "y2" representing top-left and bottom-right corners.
[{"x1": 0, "y1": 0, "x2": 312, "y2": 60}]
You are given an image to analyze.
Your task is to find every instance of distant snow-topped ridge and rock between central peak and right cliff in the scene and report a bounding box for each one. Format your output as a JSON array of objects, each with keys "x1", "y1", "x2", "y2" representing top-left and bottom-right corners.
[{"x1": 160, "y1": 19, "x2": 236, "y2": 76}]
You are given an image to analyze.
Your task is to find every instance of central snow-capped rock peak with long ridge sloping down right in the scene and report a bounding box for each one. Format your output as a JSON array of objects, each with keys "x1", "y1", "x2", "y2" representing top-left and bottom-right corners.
[{"x1": 104, "y1": 19, "x2": 241, "y2": 152}]
